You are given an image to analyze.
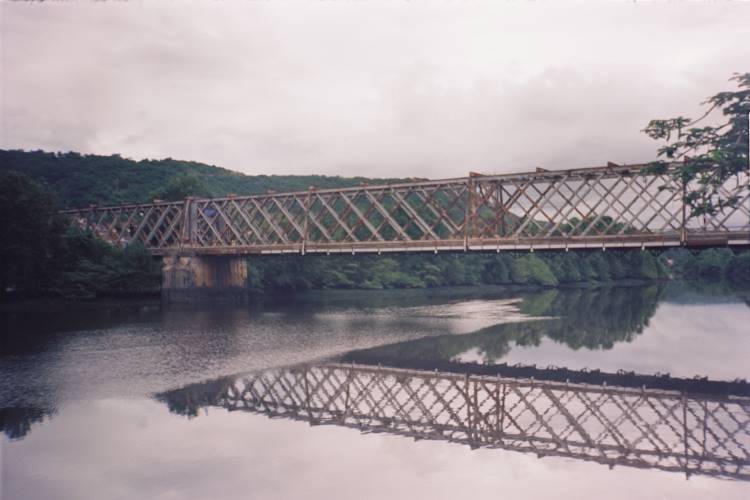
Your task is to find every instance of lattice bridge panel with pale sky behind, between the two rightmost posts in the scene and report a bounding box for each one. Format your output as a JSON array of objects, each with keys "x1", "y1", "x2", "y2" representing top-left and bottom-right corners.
[{"x1": 470, "y1": 170, "x2": 682, "y2": 239}]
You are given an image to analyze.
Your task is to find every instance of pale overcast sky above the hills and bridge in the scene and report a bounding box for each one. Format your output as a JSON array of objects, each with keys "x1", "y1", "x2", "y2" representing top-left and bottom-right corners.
[{"x1": 0, "y1": 1, "x2": 750, "y2": 178}]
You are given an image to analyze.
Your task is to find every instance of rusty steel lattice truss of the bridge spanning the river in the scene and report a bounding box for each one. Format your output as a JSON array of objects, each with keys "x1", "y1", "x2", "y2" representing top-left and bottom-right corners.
[{"x1": 62, "y1": 165, "x2": 750, "y2": 255}]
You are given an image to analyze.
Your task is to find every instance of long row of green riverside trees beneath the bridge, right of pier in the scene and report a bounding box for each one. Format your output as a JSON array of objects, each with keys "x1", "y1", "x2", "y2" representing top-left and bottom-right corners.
[{"x1": 248, "y1": 251, "x2": 667, "y2": 291}]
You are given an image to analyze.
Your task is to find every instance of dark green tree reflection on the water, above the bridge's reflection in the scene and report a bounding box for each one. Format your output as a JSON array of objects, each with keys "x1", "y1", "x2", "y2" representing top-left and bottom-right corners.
[{"x1": 340, "y1": 286, "x2": 663, "y2": 362}]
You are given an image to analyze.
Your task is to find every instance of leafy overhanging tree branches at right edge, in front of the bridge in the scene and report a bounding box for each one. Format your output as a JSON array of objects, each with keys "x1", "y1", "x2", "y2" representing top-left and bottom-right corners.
[{"x1": 643, "y1": 73, "x2": 750, "y2": 217}]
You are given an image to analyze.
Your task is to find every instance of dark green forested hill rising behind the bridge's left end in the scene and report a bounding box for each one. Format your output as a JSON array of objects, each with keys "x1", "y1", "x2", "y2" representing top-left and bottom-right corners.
[{"x1": 0, "y1": 150, "x2": 412, "y2": 208}]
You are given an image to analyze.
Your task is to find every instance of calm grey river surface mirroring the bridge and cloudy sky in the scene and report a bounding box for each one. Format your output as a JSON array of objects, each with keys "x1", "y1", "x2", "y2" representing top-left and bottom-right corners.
[{"x1": 0, "y1": 286, "x2": 750, "y2": 500}]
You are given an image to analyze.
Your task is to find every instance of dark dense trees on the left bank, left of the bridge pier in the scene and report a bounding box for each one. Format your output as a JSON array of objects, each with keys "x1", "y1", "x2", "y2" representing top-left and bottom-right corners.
[{"x1": 0, "y1": 172, "x2": 160, "y2": 297}]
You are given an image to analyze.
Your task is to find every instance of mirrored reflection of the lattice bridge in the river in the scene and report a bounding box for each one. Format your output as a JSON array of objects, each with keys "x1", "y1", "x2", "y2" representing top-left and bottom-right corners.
[{"x1": 157, "y1": 364, "x2": 750, "y2": 481}]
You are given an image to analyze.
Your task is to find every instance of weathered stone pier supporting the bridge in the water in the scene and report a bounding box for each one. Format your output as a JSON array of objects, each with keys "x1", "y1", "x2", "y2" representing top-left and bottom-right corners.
[{"x1": 161, "y1": 254, "x2": 247, "y2": 302}]
